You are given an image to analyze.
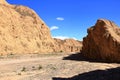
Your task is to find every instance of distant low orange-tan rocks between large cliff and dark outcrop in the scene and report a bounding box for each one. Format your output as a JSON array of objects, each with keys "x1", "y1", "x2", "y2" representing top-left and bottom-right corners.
[{"x1": 54, "y1": 39, "x2": 82, "y2": 52}]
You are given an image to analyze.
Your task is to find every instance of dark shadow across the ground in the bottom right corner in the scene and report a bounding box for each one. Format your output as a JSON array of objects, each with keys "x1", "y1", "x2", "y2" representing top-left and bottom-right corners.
[{"x1": 52, "y1": 67, "x2": 120, "y2": 80}]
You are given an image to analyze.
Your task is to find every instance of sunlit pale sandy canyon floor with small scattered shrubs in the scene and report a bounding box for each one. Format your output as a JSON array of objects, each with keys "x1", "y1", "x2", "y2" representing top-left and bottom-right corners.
[{"x1": 0, "y1": 53, "x2": 120, "y2": 80}]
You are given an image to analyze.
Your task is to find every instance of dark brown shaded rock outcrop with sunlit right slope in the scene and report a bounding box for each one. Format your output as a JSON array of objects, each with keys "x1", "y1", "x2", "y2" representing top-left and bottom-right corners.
[{"x1": 81, "y1": 19, "x2": 120, "y2": 62}]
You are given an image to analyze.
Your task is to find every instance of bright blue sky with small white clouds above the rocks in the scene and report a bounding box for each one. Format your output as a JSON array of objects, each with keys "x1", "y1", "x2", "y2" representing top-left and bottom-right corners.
[{"x1": 7, "y1": 0, "x2": 120, "y2": 40}]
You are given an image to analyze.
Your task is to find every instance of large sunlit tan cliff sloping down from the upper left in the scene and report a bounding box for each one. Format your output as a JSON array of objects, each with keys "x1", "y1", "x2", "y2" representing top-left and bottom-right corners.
[{"x1": 0, "y1": 0, "x2": 81, "y2": 54}]
